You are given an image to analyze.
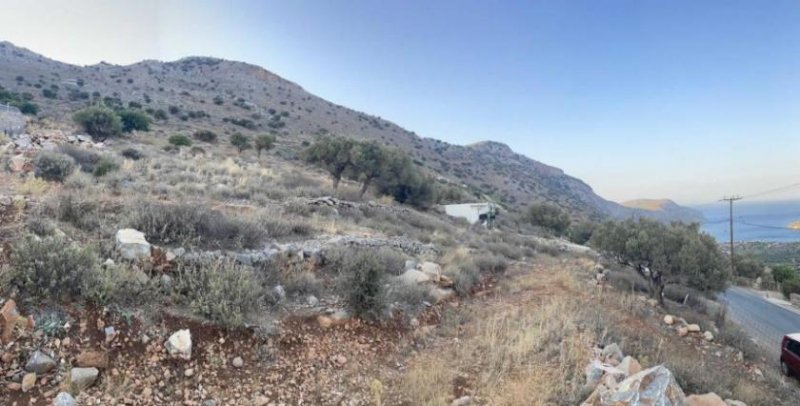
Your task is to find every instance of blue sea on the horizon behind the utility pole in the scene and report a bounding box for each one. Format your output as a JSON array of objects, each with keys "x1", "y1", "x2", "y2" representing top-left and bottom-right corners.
[{"x1": 694, "y1": 200, "x2": 800, "y2": 242}]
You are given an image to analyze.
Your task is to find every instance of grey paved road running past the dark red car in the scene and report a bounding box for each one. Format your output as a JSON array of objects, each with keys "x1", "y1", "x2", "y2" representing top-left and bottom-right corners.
[{"x1": 721, "y1": 287, "x2": 800, "y2": 354}]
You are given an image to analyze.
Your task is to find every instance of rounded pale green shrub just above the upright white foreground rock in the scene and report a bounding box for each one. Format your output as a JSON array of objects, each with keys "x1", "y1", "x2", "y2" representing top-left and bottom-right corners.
[{"x1": 176, "y1": 260, "x2": 265, "y2": 326}]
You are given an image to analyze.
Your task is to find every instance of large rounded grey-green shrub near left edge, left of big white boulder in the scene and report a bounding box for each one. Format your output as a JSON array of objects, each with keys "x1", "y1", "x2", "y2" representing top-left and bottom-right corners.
[{"x1": 11, "y1": 237, "x2": 98, "y2": 299}]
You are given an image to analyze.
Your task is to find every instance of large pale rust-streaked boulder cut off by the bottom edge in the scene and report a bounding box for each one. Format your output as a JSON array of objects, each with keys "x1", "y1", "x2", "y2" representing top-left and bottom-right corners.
[{"x1": 584, "y1": 365, "x2": 686, "y2": 406}]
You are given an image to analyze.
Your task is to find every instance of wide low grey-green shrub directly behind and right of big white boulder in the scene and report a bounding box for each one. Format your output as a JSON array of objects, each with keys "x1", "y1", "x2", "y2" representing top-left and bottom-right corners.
[{"x1": 131, "y1": 203, "x2": 264, "y2": 248}]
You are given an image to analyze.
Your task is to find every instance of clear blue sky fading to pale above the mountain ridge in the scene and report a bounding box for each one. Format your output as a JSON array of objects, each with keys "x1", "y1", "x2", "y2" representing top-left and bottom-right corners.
[{"x1": 0, "y1": 0, "x2": 800, "y2": 204}]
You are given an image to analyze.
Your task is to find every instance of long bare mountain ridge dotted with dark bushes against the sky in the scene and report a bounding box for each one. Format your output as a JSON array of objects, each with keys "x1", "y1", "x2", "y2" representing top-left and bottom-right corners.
[{"x1": 0, "y1": 42, "x2": 646, "y2": 217}]
